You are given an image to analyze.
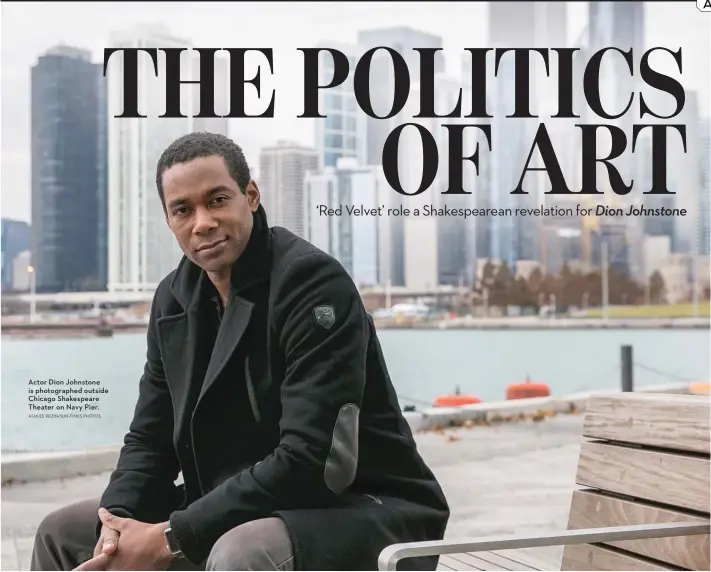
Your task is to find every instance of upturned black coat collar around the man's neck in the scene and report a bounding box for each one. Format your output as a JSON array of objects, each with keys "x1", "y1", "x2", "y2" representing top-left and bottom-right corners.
[{"x1": 170, "y1": 204, "x2": 271, "y2": 310}]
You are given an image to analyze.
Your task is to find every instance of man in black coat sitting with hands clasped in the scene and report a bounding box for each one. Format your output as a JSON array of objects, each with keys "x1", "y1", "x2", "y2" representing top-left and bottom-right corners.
[{"x1": 32, "y1": 133, "x2": 449, "y2": 570}]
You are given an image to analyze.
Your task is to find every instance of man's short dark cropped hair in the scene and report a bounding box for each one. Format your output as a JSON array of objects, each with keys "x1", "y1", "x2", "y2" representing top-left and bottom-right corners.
[{"x1": 156, "y1": 132, "x2": 251, "y2": 209}]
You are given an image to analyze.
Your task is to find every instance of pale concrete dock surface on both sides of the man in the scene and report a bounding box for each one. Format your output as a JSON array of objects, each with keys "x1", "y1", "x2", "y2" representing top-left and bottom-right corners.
[{"x1": 0, "y1": 415, "x2": 582, "y2": 570}]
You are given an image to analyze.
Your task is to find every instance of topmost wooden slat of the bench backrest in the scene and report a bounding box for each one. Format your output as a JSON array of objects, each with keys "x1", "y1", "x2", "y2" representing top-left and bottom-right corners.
[{"x1": 583, "y1": 393, "x2": 711, "y2": 454}]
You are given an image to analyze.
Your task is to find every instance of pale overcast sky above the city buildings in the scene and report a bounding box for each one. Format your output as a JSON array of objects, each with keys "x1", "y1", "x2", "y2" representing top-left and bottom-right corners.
[{"x1": 0, "y1": 1, "x2": 711, "y2": 220}]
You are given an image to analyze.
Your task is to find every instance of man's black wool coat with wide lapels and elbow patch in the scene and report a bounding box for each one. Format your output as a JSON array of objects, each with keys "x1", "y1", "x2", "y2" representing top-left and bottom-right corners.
[{"x1": 97, "y1": 206, "x2": 449, "y2": 570}]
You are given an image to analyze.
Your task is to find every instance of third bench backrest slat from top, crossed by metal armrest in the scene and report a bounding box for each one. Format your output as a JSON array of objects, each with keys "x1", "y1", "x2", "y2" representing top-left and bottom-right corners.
[{"x1": 568, "y1": 491, "x2": 711, "y2": 570}]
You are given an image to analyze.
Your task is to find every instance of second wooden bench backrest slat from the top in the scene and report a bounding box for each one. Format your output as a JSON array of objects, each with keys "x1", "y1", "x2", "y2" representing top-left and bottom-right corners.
[{"x1": 576, "y1": 442, "x2": 711, "y2": 514}]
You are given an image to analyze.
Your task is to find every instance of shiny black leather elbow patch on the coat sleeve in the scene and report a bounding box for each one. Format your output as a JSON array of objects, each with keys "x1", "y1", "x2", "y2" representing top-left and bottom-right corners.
[{"x1": 323, "y1": 403, "x2": 360, "y2": 495}]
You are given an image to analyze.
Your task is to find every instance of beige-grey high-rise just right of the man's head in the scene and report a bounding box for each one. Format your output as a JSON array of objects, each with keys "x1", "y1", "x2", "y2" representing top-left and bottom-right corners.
[{"x1": 259, "y1": 141, "x2": 318, "y2": 237}]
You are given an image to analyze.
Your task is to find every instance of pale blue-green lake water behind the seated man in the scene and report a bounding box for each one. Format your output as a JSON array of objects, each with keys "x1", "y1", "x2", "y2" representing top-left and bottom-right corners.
[{"x1": 2, "y1": 329, "x2": 711, "y2": 452}]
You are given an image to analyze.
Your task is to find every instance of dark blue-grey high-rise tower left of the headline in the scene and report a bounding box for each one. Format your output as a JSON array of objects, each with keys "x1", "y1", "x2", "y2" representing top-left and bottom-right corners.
[{"x1": 30, "y1": 46, "x2": 107, "y2": 292}]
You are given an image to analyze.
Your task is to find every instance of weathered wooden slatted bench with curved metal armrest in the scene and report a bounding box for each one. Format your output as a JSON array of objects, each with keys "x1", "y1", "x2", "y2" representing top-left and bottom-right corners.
[{"x1": 378, "y1": 393, "x2": 711, "y2": 570}]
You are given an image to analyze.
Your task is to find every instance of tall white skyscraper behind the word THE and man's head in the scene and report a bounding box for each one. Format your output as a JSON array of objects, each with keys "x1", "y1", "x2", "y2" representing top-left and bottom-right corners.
[{"x1": 107, "y1": 25, "x2": 229, "y2": 291}]
